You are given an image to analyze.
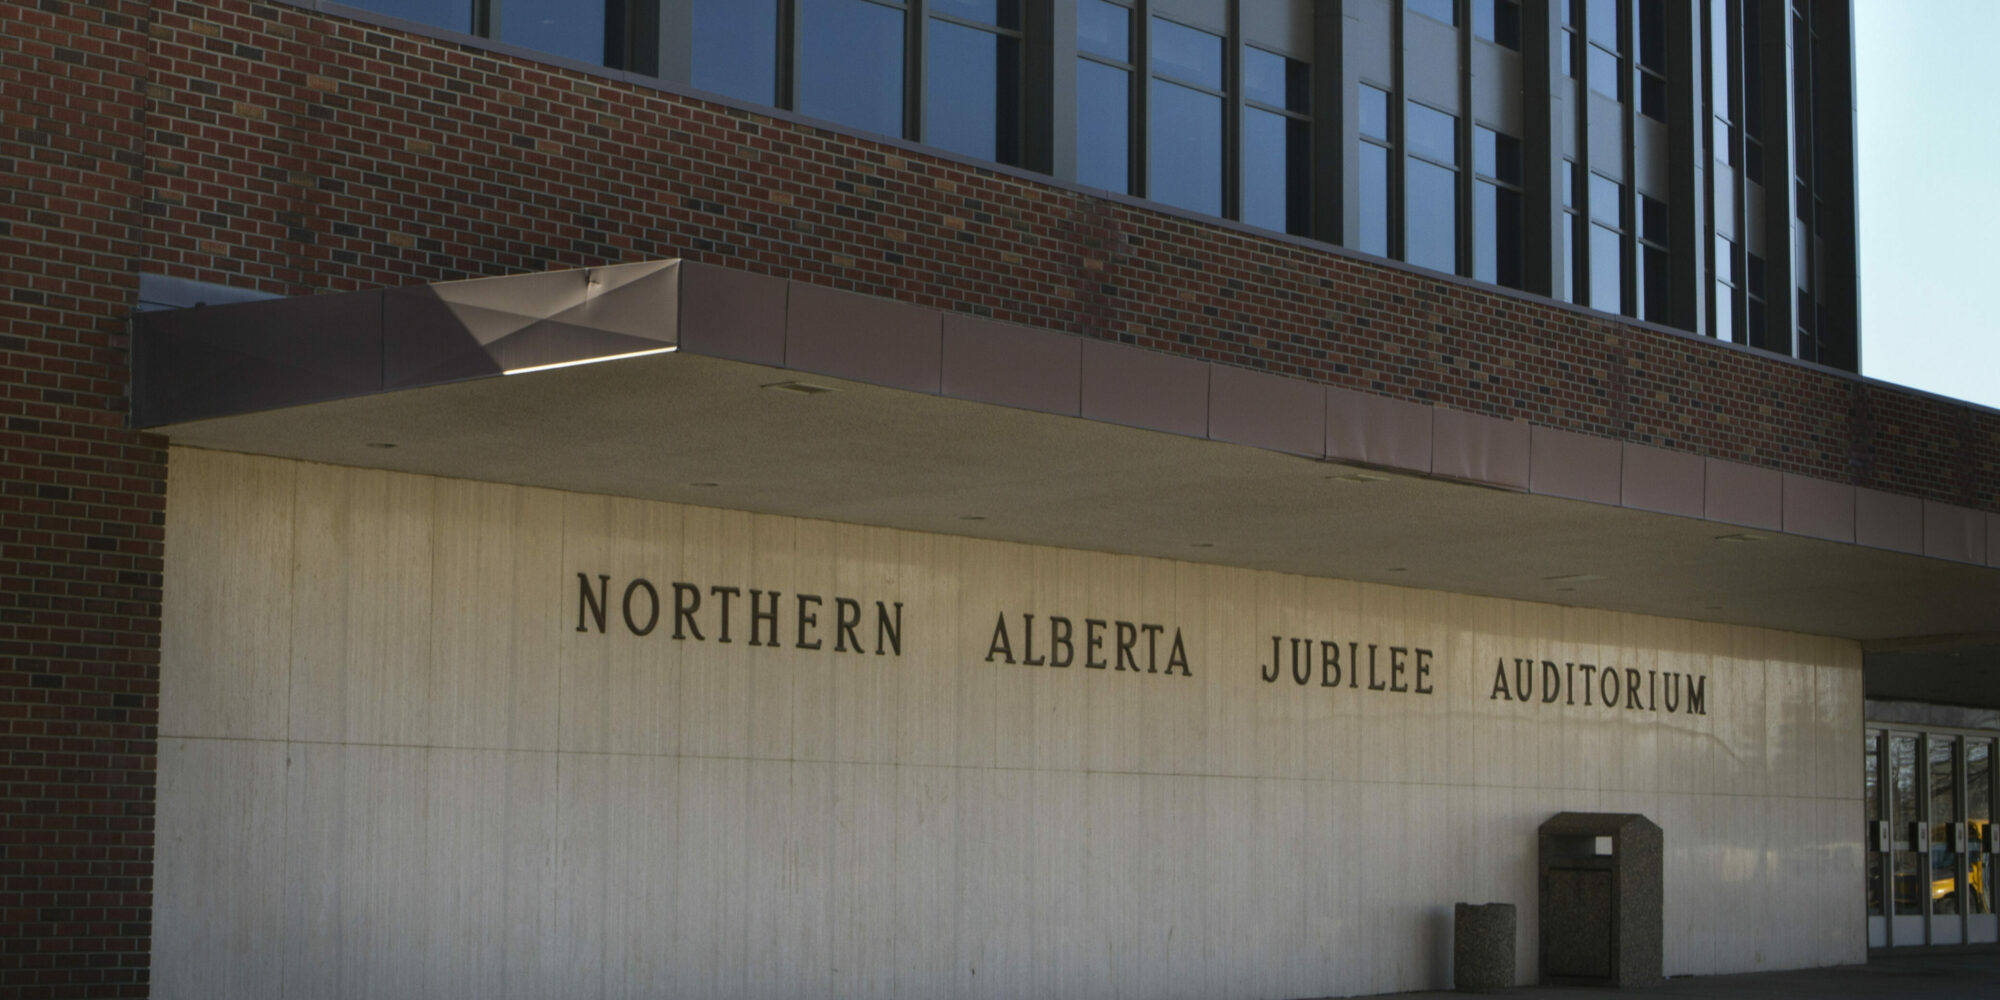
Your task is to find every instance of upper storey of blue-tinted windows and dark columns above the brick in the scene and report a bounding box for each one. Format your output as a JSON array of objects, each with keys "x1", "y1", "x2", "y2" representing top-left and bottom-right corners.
[{"x1": 320, "y1": 0, "x2": 1858, "y2": 370}]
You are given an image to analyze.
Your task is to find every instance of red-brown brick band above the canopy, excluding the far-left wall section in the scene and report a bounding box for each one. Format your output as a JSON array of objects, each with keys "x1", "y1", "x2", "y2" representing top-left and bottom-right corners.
[{"x1": 146, "y1": 0, "x2": 2000, "y2": 510}]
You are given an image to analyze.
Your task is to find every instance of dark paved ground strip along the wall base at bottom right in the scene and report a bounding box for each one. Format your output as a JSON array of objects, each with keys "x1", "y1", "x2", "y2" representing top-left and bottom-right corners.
[{"x1": 1368, "y1": 952, "x2": 2000, "y2": 1000}]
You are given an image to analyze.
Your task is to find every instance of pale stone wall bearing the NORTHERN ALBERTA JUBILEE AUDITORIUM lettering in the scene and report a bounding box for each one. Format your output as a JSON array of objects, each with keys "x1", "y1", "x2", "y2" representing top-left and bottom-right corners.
[{"x1": 154, "y1": 450, "x2": 1864, "y2": 998}]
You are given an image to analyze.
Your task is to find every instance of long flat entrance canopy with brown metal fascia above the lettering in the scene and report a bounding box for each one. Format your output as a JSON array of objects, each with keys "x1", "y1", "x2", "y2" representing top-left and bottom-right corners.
[{"x1": 134, "y1": 262, "x2": 2000, "y2": 704}]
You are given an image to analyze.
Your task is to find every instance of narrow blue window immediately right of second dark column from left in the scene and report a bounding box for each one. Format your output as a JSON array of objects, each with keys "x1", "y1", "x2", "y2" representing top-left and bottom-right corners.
[{"x1": 1076, "y1": 0, "x2": 1134, "y2": 194}]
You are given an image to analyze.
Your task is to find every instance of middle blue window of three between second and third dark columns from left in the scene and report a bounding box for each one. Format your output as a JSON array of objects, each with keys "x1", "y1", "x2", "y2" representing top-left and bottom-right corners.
[{"x1": 1146, "y1": 18, "x2": 1222, "y2": 216}]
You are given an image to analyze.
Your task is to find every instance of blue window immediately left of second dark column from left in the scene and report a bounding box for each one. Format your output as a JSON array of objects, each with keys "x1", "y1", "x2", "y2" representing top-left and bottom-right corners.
[{"x1": 924, "y1": 12, "x2": 1020, "y2": 164}]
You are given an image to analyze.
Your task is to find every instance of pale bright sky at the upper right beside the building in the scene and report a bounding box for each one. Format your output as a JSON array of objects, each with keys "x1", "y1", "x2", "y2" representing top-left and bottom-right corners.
[{"x1": 1854, "y1": 0, "x2": 2000, "y2": 410}]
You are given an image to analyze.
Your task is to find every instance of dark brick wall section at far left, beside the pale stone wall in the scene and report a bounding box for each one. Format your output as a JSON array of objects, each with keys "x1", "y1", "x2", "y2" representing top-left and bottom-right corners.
[{"x1": 0, "y1": 0, "x2": 166, "y2": 998}]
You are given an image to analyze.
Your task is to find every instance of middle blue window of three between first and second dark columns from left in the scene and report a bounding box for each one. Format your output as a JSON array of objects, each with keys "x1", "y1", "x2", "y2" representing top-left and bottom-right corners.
[{"x1": 798, "y1": 0, "x2": 904, "y2": 136}]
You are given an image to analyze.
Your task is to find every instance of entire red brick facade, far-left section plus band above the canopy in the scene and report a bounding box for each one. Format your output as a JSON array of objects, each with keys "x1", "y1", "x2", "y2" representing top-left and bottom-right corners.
[{"x1": 0, "y1": 0, "x2": 2000, "y2": 996}]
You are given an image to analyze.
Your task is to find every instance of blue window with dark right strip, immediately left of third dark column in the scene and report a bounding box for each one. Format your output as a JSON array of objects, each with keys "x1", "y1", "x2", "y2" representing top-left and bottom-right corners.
[{"x1": 1242, "y1": 46, "x2": 1312, "y2": 234}]
